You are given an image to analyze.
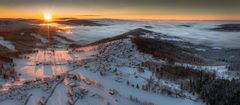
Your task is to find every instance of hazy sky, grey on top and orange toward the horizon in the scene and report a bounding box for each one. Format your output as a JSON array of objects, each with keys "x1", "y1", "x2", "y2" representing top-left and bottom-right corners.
[{"x1": 0, "y1": 0, "x2": 240, "y2": 20}]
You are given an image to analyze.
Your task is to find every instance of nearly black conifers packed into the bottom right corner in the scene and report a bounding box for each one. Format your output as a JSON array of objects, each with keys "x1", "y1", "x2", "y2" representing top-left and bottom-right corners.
[{"x1": 189, "y1": 79, "x2": 240, "y2": 105}]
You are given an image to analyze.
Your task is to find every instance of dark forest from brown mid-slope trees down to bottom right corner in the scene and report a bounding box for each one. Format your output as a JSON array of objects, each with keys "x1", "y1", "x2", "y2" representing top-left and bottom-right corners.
[{"x1": 152, "y1": 65, "x2": 240, "y2": 105}]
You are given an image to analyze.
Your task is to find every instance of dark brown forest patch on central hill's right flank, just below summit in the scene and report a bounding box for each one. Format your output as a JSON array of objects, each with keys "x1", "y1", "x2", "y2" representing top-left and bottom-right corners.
[{"x1": 132, "y1": 37, "x2": 204, "y2": 64}]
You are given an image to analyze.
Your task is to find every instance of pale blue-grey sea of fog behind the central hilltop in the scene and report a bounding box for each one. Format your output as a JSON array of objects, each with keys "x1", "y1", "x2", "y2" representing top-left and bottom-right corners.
[{"x1": 59, "y1": 20, "x2": 240, "y2": 48}]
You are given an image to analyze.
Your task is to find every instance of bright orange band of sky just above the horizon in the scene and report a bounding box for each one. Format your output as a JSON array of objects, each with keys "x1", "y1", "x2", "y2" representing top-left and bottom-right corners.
[{"x1": 0, "y1": 10, "x2": 240, "y2": 20}]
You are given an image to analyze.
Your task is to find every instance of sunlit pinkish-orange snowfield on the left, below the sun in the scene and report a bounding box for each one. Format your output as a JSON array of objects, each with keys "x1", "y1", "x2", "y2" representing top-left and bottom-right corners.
[{"x1": 14, "y1": 49, "x2": 93, "y2": 78}]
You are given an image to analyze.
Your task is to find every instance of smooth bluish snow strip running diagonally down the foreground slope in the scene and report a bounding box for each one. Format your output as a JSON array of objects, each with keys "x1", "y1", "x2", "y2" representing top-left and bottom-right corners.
[{"x1": 75, "y1": 70, "x2": 201, "y2": 105}]
